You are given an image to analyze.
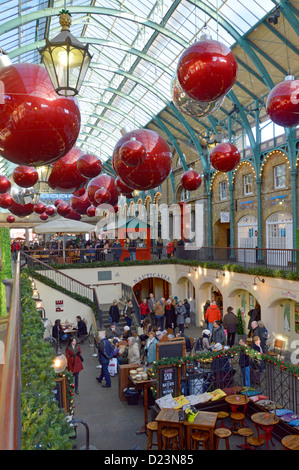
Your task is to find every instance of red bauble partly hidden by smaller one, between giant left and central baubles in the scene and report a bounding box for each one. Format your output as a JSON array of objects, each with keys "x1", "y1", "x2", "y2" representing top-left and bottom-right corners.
[{"x1": 48, "y1": 147, "x2": 87, "y2": 193}]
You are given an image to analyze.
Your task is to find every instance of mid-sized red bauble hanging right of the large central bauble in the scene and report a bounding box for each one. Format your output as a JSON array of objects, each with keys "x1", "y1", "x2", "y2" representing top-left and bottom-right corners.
[{"x1": 210, "y1": 142, "x2": 241, "y2": 172}]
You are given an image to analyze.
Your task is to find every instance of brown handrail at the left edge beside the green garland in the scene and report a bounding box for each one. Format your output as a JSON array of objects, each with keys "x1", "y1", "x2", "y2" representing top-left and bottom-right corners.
[{"x1": 0, "y1": 254, "x2": 21, "y2": 450}]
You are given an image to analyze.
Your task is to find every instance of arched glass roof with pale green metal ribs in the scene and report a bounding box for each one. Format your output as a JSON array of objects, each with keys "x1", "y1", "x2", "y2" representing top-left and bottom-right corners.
[{"x1": 0, "y1": 0, "x2": 298, "y2": 176}]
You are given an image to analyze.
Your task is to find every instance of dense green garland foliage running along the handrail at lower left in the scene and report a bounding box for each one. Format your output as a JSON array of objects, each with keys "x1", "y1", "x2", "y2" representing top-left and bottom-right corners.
[{"x1": 21, "y1": 272, "x2": 73, "y2": 450}]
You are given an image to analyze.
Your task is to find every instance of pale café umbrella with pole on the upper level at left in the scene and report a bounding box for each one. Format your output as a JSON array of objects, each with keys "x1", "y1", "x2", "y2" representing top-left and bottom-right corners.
[{"x1": 33, "y1": 217, "x2": 96, "y2": 262}]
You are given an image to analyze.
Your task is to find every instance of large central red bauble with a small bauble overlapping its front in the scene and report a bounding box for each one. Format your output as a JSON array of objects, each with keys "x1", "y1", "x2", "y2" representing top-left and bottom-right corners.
[{"x1": 112, "y1": 129, "x2": 172, "y2": 190}]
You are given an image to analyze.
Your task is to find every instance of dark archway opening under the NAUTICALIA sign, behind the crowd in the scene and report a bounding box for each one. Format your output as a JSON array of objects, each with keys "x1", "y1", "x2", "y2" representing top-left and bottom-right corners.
[{"x1": 133, "y1": 276, "x2": 172, "y2": 304}]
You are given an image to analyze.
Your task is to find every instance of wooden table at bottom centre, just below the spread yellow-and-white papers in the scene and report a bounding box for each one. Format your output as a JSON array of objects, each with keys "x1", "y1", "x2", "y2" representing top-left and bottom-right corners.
[{"x1": 156, "y1": 408, "x2": 218, "y2": 450}]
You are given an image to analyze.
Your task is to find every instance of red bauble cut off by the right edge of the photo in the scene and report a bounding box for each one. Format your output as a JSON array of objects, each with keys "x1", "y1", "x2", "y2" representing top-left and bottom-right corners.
[{"x1": 266, "y1": 75, "x2": 299, "y2": 127}]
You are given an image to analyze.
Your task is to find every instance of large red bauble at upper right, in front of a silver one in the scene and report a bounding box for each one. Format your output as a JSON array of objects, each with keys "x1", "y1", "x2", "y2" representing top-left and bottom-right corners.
[{"x1": 177, "y1": 36, "x2": 238, "y2": 101}]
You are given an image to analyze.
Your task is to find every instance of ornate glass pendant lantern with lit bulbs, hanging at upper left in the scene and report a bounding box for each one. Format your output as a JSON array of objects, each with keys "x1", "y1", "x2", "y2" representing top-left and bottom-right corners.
[{"x1": 39, "y1": 10, "x2": 92, "y2": 96}]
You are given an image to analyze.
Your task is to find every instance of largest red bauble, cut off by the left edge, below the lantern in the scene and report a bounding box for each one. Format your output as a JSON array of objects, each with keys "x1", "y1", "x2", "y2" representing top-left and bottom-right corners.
[{"x1": 0, "y1": 63, "x2": 81, "y2": 166}]
